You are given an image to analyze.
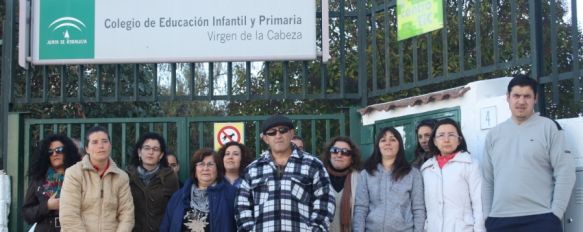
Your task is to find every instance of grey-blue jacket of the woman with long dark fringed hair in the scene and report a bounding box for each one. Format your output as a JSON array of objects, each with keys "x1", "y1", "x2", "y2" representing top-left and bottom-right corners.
[{"x1": 352, "y1": 164, "x2": 425, "y2": 232}]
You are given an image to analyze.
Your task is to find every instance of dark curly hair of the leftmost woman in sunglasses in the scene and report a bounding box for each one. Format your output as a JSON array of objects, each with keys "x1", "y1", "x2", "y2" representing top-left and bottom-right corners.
[{"x1": 28, "y1": 134, "x2": 81, "y2": 180}]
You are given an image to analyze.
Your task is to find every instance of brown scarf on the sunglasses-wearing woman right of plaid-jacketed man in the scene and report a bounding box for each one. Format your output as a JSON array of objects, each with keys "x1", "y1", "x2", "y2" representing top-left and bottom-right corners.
[{"x1": 326, "y1": 167, "x2": 352, "y2": 232}]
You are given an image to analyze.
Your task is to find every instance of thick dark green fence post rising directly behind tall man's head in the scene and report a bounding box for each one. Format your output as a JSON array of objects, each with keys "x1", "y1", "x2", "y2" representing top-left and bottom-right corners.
[{"x1": 528, "y1": 0, "x2": 546, "y2": 116}]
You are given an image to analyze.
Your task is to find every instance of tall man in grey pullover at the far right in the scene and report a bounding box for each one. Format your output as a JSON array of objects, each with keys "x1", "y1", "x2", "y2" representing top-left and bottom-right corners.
[{"x1": 483, "y1": 75, "x2": 575, "y2": 232}]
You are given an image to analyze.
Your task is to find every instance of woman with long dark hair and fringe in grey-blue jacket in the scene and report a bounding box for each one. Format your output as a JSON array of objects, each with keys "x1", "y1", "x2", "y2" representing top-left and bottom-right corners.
[{"x1": 352, "y1": 127, "x2": 425, "y2": 232}]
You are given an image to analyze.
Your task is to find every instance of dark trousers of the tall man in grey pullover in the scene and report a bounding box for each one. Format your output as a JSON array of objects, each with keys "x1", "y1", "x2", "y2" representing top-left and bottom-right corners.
[{"x1": 486, "y1": 213, "x2": 563, "y2": 232}]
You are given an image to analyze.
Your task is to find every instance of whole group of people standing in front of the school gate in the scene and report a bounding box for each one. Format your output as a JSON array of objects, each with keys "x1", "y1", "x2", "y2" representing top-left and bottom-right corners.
[{"x1": 22, "y1": 75, "x2": 575, "y2": 232}]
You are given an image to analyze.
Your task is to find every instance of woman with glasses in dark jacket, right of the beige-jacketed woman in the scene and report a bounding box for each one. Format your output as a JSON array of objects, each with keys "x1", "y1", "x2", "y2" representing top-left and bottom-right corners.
[{"x1": 128, "y1": 132, "x2": 178, "y2": 232}]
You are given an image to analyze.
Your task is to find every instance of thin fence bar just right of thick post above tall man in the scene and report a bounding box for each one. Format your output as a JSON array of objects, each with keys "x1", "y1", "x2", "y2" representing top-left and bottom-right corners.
[{"x1": 549, "y1": 0, "x2": 559, "y2": 104}]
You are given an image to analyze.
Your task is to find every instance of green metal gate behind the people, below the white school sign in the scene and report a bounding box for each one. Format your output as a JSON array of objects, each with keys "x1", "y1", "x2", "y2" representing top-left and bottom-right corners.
[{"x1": 11, "y1": 113, "x2": 346, "y2": 231}]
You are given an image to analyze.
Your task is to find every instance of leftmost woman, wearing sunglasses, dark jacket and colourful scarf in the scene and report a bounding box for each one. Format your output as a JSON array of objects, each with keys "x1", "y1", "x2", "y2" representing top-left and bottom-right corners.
[{"x1": 22, "y1": 135, "x2": 81, "y2": 232}]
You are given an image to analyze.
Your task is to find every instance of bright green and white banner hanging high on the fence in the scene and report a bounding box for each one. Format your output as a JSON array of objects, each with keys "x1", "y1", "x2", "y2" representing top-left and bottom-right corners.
[{"x1": 397, "y1": 0, "x2": 443, "y2": 41}]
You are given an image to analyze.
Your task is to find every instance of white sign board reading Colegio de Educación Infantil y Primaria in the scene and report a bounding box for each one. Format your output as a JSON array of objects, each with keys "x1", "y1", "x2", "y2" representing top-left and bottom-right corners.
[{"x1": 31, "y1": 0, "x2": 317, "y2": 64}]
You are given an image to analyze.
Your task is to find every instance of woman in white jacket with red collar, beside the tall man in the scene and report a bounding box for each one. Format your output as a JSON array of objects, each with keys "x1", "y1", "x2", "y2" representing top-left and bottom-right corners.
[{"x1": 421, "y1": 119, "x2": 486, "y2": 232}]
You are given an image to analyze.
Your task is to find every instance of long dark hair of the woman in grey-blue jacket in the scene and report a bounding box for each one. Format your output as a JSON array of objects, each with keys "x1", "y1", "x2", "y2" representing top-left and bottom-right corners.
[{"x1": 364, "y1": 127, "x2": 411, "y2": 181}]
